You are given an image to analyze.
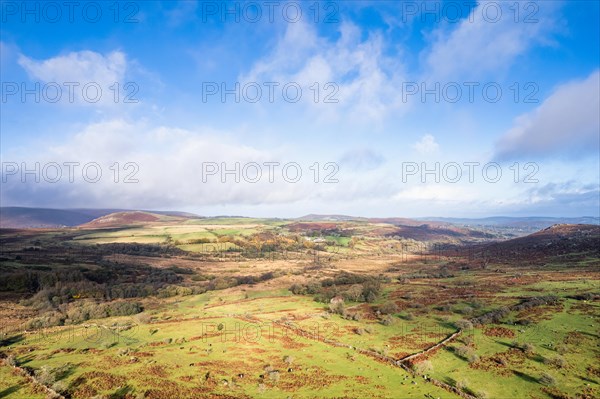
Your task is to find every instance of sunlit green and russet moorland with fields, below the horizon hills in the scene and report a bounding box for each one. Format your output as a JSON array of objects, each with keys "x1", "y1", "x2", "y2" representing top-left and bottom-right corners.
[{"x1": 0, "y1": 219, "x2": 600, "y2": 398}]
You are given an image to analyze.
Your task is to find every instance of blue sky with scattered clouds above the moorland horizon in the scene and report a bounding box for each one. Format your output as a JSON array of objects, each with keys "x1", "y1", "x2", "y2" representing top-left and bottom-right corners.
[{"x1": 0, "y1": 0, "x2": 600, "y2": 218}]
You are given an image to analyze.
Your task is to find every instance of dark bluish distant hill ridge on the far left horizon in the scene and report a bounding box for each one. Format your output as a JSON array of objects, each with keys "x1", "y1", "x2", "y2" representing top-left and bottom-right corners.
[{"x1": 0, "y1": 207, "x2": 198, "y2": 229}]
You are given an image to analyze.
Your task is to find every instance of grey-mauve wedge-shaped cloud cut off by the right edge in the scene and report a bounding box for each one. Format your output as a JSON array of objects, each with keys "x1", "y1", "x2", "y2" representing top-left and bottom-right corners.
[{"x1": 495, "y1": 71, "x2": 600, "y2": 159}]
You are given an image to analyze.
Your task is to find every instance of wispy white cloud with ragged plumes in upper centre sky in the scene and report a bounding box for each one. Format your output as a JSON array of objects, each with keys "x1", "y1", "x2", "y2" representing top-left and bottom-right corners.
[{"x1": 239, "y1": 18, "x2": 405, "y2": 123}]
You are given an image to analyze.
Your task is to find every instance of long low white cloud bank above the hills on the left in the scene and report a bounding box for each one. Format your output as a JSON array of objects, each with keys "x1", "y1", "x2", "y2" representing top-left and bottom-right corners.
[{"x1": 2, "y1": 119, "x2": 390, "y2": 209}]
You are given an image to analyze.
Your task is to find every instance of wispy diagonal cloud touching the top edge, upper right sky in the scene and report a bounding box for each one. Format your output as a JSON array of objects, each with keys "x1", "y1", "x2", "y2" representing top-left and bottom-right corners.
[{"x1": 425, "y1": 0, "x2": 560, "y2": 80}]
